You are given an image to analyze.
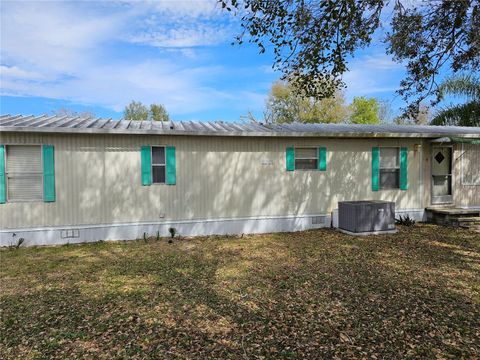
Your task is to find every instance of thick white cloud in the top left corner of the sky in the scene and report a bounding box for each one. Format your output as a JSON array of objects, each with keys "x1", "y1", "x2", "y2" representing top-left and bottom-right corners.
[{"x1": 1, "y1": 2, "x2": 124, "y2": 73}]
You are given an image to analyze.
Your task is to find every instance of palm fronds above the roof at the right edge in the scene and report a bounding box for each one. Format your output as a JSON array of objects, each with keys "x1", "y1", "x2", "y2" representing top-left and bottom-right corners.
[{"x1": 432, "y1": 75, "x2": 480, "y2": 126}]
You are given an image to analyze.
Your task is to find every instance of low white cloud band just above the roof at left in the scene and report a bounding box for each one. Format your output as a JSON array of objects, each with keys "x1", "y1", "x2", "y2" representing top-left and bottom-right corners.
[{"x1": 2, "y1": 61, "x2": 234, "y2": 114}]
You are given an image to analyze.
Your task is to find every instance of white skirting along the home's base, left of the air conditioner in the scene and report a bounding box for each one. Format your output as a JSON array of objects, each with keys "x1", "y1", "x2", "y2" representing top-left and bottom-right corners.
[{"x1": 0, "y1": 214, "x2": 331, "y2": 247}]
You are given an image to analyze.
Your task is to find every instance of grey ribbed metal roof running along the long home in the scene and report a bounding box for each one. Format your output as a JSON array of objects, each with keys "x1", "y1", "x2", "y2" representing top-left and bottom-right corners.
[{"x1": 0, "y1": 115, "x2": 480, "y2": 138}]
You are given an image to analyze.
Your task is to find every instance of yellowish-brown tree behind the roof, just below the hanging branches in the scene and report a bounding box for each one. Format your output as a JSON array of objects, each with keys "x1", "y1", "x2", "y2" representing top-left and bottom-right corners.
[{"x1": 265, "y1": 81, "x2": 348, "y2": 123}]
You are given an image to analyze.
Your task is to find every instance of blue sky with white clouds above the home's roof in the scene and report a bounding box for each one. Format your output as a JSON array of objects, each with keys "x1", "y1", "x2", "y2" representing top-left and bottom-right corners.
[{"x1": 0, "y1": 0, "x2": 404, "y2": 121}]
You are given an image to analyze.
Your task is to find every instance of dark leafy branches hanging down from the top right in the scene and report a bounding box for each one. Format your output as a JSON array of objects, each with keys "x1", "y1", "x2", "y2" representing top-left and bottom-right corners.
[{"x1": 219, "y1": 0, "x2": 480, "y2": 113}]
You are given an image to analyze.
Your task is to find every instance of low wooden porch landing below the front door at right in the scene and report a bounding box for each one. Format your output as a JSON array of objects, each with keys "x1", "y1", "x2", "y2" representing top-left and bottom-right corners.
[{"x1": 425, "y1": 207, "x2": 480, "y2": 230}]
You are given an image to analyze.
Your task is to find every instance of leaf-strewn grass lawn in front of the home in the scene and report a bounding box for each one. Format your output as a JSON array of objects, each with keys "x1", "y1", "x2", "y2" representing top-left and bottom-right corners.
[{"x1": 0, "y1": 225, "x2": 480, "y2": 359}]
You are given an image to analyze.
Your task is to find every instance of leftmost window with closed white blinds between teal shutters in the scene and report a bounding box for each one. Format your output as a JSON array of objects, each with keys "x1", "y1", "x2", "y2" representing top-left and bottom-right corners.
[{"x1": 5, "y1": 145, "x2": 43, "y2": 202}]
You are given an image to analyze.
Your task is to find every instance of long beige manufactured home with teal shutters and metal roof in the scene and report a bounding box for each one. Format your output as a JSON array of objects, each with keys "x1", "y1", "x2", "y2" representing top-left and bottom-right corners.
[{"x1": 0, "y1": 115, "x2": 480, "y2": 246}]
